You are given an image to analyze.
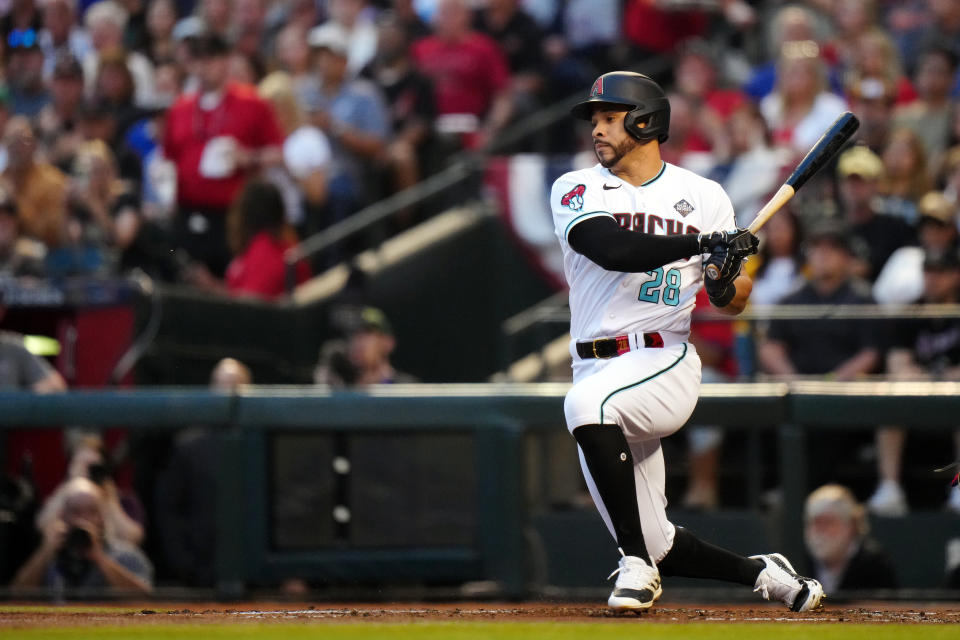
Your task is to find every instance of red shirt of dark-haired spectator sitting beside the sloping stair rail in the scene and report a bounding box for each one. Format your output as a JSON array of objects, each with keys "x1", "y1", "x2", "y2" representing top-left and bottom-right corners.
[{"x1": 227, "y1": 231, "x2": 310, "y2": 300}]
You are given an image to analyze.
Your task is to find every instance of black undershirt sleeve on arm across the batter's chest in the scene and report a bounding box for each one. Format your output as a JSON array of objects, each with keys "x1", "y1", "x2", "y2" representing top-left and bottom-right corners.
[{"x1": 567, "y1": 216, "x2": 700, "y2": 273}]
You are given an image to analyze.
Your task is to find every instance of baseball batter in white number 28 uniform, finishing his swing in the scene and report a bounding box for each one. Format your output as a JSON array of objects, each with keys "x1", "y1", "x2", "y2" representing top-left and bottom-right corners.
[{"x1": 550, "y1": 71, "x2": 824, "y2": 611}]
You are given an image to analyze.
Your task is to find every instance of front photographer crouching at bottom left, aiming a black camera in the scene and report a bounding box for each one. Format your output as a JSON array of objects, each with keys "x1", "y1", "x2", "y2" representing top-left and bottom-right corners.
[{"x1": 11, "y1": 477, "x2": 153, "y2": 594}]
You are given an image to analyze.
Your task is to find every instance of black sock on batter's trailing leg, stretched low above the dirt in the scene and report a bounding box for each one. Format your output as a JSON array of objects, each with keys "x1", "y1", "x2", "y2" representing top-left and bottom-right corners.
[{"x1": 657, "y1": 527, "x2": 766, "y2": 587}]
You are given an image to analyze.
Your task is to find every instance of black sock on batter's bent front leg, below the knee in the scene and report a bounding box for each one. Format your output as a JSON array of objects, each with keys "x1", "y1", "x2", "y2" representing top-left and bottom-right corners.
[{"x1": 573, "y1": 424, "x2": 650, "y2": 562}]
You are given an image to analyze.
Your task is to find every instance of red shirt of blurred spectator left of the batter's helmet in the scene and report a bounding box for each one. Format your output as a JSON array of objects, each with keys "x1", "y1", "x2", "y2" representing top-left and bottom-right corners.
[{"x1": 411, "y1": 32, "x2": 510, "y2": 118}]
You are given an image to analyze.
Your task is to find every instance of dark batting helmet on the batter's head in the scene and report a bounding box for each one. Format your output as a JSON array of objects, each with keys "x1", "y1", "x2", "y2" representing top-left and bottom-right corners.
[{"x1": 570, "y1": 71, "x2": 670, "y2": 143}]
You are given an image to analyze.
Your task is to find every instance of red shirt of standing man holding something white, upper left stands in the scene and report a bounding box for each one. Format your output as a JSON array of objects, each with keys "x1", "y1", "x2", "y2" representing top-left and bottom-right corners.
[{"x1": 163, "y1": 84, "x2": 283, "y2": 209}]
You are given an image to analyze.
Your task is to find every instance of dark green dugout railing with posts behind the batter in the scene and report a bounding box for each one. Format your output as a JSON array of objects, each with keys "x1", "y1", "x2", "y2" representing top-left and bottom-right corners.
[{"x1": 0, "y1": 382, "x2": 960, "y2": 597}]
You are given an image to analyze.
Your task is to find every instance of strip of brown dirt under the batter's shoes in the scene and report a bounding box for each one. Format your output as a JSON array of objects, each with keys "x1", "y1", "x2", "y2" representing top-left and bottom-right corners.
[{"x1": 0, "y1": 602, "x2": 960, "y2": 629}]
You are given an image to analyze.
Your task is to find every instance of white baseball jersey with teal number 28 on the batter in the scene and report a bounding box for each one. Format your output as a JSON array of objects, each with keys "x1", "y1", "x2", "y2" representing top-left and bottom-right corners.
[{"x1": 550, "y1": 162, "x2": 736, "y2": 350}]
